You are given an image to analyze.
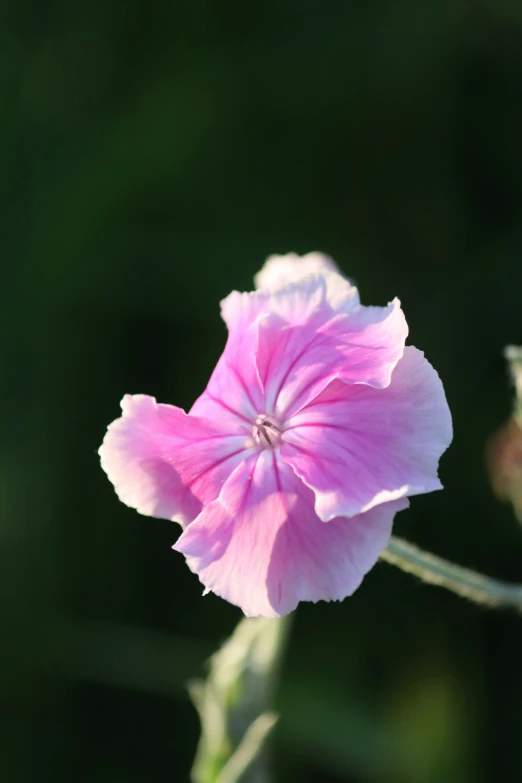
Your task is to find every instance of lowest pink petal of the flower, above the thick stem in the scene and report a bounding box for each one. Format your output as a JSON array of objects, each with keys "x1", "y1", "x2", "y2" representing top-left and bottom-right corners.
[{"x1": 174, "y1": 450, "x2": 407, "y2": 617}]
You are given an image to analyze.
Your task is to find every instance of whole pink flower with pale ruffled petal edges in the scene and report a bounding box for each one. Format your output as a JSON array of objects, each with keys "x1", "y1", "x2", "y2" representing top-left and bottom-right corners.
[{"x1": 100, "y1": 254, "x2": 452, "y2": 617}]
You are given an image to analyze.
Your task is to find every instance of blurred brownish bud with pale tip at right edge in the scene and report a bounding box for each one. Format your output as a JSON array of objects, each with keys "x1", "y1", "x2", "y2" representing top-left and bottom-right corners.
[{"x1": 486, "y1": 345, "x2": 522, "y2": 523}]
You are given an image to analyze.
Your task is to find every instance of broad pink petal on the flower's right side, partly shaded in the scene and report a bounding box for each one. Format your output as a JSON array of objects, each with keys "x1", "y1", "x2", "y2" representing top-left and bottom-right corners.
[{"x1": 281, "y1": 347, "x2": 452, "y2": 521}]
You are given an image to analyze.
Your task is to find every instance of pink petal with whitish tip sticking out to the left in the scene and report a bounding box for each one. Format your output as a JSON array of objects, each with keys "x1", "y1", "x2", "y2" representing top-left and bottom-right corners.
[{"x1": 99, "y1": 394, "x2": 254, "y2": 524}]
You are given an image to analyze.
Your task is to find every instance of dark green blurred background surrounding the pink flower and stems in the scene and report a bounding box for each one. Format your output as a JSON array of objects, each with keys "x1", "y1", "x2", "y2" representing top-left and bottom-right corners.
[{"x1": 0, "y1": 0, "x2": 522, "y2": 783}]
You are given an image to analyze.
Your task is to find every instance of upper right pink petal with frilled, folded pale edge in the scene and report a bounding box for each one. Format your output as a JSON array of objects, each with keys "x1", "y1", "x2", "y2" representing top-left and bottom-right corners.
[{"x1": 257, "y1": 299, "x2": 408, "y2": 419}]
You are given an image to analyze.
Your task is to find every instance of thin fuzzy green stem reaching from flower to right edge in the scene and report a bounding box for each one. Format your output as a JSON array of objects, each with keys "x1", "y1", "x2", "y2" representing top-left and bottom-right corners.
[{"x1": 381, "y1": 536, "x2": 522, "y2": 612}]
